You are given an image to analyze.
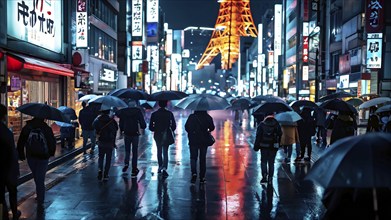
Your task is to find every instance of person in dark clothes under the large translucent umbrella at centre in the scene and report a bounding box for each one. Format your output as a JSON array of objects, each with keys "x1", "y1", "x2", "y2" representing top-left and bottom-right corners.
[{"x1": 185, "y1": 111, "x2": 215, "y2": 183}]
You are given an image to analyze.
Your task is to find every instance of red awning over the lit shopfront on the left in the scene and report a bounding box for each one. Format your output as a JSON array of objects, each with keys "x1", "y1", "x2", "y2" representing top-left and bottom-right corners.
[{"x1": 7, "y1": 53, "x2": 74, "y2": 77}]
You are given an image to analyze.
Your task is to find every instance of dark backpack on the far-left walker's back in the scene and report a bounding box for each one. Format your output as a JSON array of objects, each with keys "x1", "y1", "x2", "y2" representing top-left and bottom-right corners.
[{"x1": 26, "y1": 128, "x2": 50, "y2": 159}]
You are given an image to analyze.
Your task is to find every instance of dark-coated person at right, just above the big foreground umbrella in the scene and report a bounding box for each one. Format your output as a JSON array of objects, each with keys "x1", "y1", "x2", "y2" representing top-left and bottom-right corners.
[{"x1": 330, "y1": 112, "x2": 357, "y2": 144}]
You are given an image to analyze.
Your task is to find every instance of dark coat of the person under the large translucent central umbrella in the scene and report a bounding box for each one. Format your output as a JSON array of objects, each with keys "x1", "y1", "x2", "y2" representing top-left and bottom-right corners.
[{"x1": 185, "y1": 111, "x2": 215, "y2": 146}]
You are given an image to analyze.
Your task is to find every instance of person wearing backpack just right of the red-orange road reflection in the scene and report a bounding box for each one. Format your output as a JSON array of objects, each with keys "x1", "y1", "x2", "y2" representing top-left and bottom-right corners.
[{"x1": 254, "y1": 115, "x2": 282, "y2": 184}]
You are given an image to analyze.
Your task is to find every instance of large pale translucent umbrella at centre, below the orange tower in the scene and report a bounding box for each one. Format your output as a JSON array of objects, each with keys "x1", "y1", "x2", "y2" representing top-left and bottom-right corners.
[{"x1": 176, "y1": 94, "x2": 229, "y2": 111}]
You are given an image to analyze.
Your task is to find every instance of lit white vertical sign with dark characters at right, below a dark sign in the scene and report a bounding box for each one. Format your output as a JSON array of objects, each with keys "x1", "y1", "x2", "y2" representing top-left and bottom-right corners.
[{"x1": 367, "y1": 33, "x2": 383, "y2": 69}]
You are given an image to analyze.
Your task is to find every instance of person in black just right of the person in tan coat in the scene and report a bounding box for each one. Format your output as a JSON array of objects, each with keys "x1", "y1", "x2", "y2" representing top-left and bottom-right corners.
[{"x1": 295, "y1": 107, "x2": 316, "y2": 162}]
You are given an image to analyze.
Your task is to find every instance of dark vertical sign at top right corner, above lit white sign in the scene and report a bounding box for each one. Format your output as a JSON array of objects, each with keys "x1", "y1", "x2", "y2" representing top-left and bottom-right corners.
[{"x1": 365, "y1": 0, "x2": 384, "y2": 33}]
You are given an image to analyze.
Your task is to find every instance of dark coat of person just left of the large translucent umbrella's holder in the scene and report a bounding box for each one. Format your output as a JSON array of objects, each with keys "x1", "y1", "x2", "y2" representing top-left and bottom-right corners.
[{"x1": 149, "y1": 108, "x2": 176, "y2": 144}]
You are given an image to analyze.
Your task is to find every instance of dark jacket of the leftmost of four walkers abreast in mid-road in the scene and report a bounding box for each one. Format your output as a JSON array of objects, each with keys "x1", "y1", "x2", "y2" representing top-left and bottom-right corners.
[{"x1": 92, "y1": 114, "x2": 118, "y2": 144}]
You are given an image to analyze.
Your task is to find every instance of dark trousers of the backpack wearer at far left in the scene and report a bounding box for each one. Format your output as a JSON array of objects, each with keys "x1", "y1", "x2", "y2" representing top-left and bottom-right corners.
[{"x1": 27, "y1": 157, "x2": 49, "y2": 205}]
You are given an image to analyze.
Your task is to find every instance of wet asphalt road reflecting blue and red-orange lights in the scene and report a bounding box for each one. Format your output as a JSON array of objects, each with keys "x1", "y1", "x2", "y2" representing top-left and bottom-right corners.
[{"x1": 13, "y1": 111, "x2": 332, "y2": 220}]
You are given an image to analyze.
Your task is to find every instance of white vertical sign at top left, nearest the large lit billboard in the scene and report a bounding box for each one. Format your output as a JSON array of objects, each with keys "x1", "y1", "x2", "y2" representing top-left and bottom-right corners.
[{"x1": 76, "y1": 0, "x2": 88, "y2": 48}]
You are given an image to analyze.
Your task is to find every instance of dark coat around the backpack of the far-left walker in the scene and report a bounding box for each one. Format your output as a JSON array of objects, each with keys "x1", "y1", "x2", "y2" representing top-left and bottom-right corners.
[{"x1": 17, "y1": 118, "x2": 56, "y2": 160}]
